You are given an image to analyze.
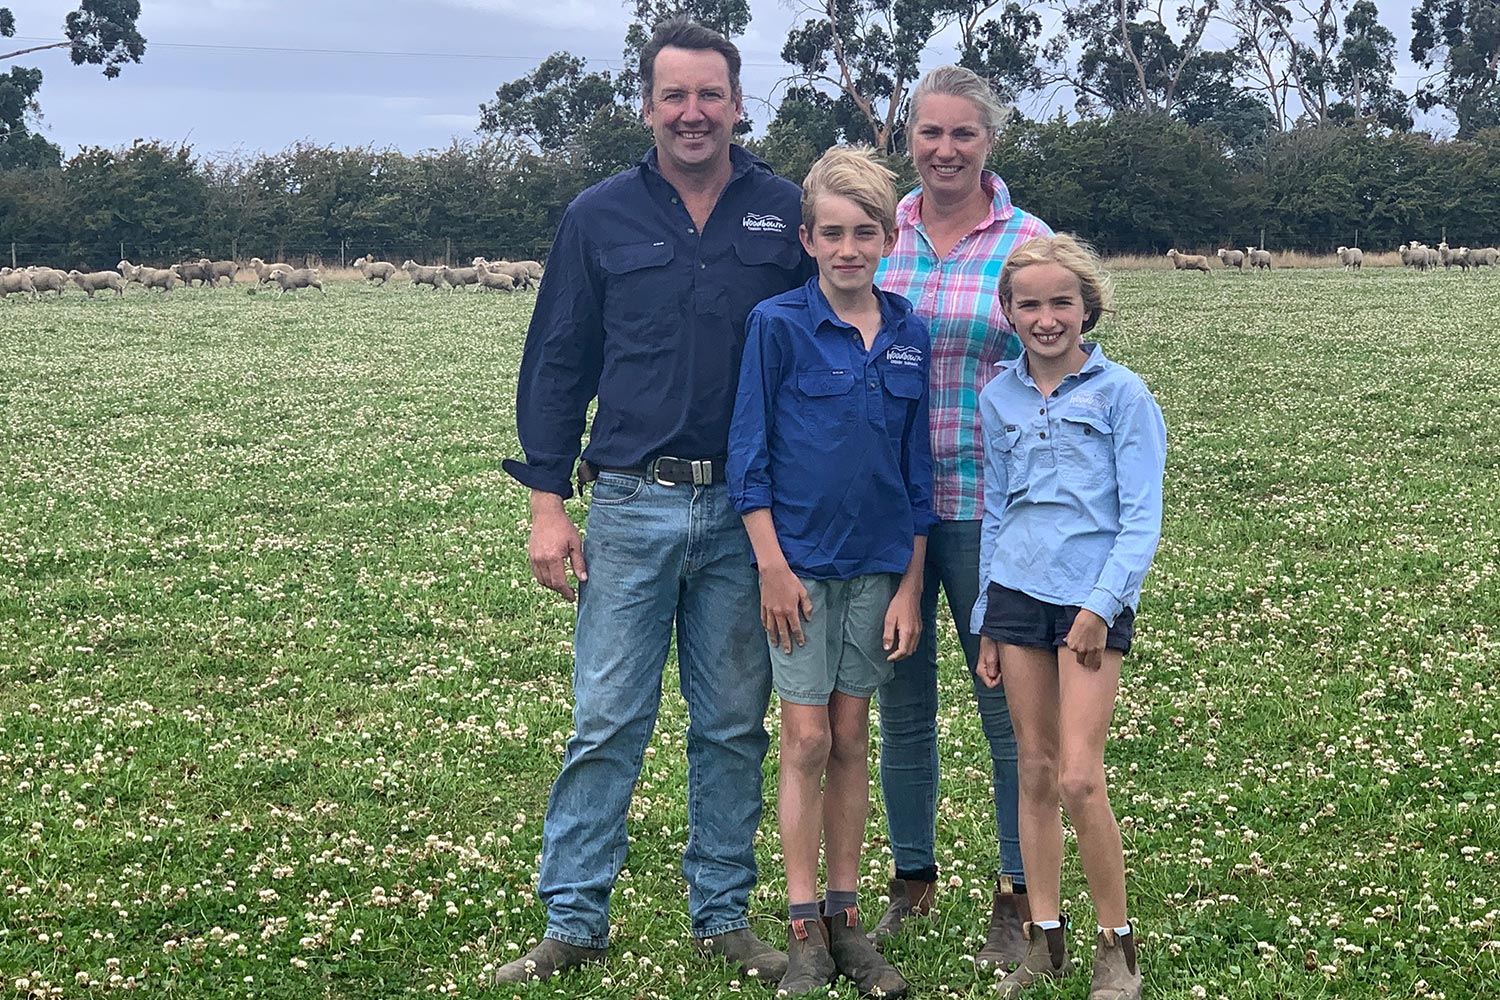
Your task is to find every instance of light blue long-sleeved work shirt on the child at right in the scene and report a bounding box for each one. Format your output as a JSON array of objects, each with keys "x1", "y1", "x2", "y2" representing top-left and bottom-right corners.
[{"x1": 971, "y1": 343, "x2": 1167, "y2": 634}]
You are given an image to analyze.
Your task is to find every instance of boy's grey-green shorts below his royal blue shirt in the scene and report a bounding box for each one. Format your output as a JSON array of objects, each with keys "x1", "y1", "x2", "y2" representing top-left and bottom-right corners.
[{"x1": 767, "y1": 573, "x2": 902, "y2": 705}]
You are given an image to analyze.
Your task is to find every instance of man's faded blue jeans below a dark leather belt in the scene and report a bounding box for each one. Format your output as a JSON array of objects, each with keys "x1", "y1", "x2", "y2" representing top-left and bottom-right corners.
[{"x1": 537, "y1": 472, "x2": 771, "y2": 948}]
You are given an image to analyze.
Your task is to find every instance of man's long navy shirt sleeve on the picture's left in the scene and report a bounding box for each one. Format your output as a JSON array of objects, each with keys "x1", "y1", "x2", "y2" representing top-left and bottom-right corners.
[{"x1": 503, "y1": 205, "x2": 605, "y2": 496}]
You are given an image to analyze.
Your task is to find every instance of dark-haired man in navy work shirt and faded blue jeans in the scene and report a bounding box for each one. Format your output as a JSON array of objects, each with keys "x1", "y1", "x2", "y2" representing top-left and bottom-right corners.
[{"x1": 497, "y1": 18, "x2": 812, "y2": 984}]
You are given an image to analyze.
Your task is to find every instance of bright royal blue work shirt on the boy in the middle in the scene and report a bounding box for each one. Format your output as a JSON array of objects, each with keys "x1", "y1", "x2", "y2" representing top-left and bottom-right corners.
[{"x1": 729, "y1": 277, "x2": 933, "y2": 580}]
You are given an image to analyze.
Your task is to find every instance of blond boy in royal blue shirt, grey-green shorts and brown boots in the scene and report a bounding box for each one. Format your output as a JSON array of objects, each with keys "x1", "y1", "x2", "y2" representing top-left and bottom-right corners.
[{"x1": 729, "y1": 148, "x2": 932, "y2": 997}]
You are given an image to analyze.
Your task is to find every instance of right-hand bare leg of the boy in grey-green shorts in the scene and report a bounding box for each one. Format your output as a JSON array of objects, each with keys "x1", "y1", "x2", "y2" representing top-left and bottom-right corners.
[{"x1": 824, "y1": 691, "x2": 870, "y2": 892}]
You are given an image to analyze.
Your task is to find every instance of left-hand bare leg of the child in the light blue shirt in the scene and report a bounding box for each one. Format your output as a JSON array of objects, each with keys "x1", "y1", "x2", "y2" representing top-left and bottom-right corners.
[{"x1": 1001, "y1": 645, "x2": 1062, "y2": 921}]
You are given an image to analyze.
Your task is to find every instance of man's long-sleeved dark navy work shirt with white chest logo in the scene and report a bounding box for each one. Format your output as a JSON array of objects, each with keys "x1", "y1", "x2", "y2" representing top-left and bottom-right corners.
[{"x1": 504, "y1": 145, "x2": 812, "y2": 496}]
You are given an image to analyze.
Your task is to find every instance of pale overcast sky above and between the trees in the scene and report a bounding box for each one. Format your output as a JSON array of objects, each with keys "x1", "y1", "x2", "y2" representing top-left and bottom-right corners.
[{"x1": 0, "y1": 0, "x2": 1452, "y2": 157}]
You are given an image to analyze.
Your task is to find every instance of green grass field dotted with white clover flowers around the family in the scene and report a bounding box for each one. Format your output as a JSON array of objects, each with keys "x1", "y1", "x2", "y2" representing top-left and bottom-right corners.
[{"x1": 0, "y1": 268, "x2": 1500, "y2": 1000}]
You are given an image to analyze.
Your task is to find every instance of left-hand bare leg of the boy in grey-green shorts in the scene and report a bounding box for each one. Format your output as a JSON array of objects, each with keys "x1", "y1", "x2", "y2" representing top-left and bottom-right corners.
[{"x1": 776, "y1": 702, "x2": 831, "y2": 903}]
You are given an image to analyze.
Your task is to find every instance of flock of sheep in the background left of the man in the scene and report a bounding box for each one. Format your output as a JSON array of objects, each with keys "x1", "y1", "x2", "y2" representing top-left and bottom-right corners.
[{"x1": 0, "y1": 255, "x2": 542, "y2": 298}]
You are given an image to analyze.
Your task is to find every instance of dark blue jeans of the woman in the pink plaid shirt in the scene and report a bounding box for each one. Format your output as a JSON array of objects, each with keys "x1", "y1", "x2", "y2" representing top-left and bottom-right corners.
[{"x1": 881, "y1": 520, "x2": 1026, "y2": 883}]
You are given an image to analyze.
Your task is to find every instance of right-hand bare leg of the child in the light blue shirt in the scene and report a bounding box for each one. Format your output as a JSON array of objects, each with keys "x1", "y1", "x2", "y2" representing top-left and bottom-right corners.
[{"x1": 1058, "y1": 648, "x2": 1127, "y2": 927}]
